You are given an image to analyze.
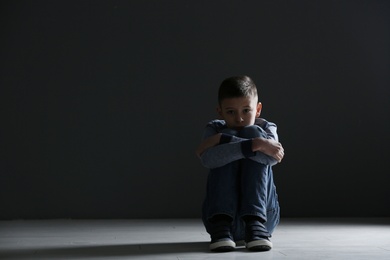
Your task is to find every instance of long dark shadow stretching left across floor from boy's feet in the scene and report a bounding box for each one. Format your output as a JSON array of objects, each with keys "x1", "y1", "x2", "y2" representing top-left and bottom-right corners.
[{"x1": 0, "y1": 242, "x2": 219, "y2": 259}]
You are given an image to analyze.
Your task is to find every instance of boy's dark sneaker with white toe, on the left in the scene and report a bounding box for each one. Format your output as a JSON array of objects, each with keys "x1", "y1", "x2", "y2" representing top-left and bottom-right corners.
[{"x1": 210, "y1": 221, "x2": 236, "y2": 252}]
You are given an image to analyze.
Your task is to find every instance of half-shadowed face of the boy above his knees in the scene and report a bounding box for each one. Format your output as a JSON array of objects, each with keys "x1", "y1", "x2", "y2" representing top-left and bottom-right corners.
[{"x1": 217, "y1": 97, "x2": 262, "y2": 130}]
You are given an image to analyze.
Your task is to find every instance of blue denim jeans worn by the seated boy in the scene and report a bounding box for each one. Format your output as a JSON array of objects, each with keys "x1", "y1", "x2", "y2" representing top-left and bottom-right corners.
[{"x1": 202, "y1": 126, "x2": 280, "y2": 241}]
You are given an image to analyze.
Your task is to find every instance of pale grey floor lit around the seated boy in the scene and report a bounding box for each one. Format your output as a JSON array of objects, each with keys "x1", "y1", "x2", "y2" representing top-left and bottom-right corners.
[{"x1": 0, "y1": 219, "x2": 390, "y2": 260}]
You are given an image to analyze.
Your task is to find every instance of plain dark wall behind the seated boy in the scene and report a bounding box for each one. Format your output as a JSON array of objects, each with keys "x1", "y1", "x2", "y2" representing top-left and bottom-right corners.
[{"x1": 0, "y1": 0, "x2": 390, "y2": 219}]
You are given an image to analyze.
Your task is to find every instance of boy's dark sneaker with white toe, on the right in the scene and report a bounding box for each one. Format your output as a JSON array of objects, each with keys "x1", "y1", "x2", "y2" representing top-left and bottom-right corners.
[{"x1": 245, "y1": 220, "x2": 272, "y2": 251}]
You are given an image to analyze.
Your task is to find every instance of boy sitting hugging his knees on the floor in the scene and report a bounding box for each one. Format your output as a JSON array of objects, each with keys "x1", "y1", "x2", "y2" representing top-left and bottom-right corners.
[{"x1": 196, "y1": 76, "x2": 284, "y2": 252}]
